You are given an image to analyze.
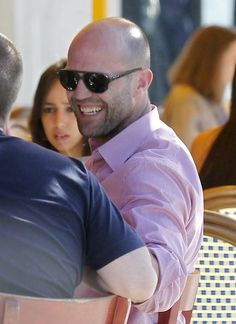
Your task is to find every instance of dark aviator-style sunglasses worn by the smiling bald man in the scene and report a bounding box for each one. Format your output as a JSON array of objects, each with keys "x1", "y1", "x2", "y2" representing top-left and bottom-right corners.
[{"x1": 58, "y1": 67, "x2": 142, "y2": 93}]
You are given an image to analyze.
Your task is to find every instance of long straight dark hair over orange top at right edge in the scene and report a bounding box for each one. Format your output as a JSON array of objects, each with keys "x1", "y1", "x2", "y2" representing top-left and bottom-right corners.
[{"x1": 199, "y1": 70, "x2": 236, "y2": 189}]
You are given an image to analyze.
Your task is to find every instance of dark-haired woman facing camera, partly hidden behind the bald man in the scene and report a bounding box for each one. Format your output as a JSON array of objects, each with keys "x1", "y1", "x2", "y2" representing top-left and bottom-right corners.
[{"x1": 29, "y1": 59, "x2": 90, "y2": 158}]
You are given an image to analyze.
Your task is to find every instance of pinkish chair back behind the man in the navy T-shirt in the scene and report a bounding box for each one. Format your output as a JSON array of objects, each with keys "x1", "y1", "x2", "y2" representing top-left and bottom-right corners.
[{"x1": 0, "y1": 294, "x2": 131, "y2": 324}]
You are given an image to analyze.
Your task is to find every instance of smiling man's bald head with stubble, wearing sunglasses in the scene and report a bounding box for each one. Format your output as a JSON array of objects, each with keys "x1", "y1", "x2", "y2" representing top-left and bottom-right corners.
[{"x1": 64, "y1": 18, "x2": 153, "y2": 141}]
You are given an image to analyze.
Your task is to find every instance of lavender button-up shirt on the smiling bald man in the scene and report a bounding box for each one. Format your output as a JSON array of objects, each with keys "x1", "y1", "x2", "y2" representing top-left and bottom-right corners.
[{"x1": 76, "y1": 107, "x2": 203, "y2": 324}]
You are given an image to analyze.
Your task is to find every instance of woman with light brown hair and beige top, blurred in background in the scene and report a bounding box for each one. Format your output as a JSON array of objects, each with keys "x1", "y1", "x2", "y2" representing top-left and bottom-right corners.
[{"x1": 161, "y1": 26, "x2": 236, "y2": 148}]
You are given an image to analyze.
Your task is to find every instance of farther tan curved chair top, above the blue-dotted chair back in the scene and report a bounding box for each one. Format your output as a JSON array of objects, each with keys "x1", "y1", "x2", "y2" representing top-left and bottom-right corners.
[{"x1": 203, "y1": 185, "x2": 236, "y2": 217}]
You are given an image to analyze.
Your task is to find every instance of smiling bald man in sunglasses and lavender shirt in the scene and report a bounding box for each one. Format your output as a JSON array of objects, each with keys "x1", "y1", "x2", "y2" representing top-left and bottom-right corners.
[{"x1": 59, "y1": 18, "x2": 203, "y2": 324}]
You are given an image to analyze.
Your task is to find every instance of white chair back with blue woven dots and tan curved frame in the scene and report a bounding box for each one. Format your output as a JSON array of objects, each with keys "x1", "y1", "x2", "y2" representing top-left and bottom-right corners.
[{"x1": 191, "y1": 210, "x2": 236, "y2": 324}]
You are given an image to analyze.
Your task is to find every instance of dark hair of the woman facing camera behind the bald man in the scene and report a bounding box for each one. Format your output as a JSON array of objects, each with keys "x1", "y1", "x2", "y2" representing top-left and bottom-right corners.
[{"x1": 29, "y1": 59, "x2": 90, "y2": 156}]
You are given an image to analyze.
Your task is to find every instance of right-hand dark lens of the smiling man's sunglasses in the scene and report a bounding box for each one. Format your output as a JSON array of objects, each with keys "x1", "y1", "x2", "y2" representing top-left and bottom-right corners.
[{"x1": 84, "y1": 73, "x2": 110, "y2": 93}]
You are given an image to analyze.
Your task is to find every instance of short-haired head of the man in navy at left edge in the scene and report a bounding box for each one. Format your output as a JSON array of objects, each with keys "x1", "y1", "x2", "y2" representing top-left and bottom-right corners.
[{"x1": 0, "y1": 33, "x2": 23, "y2": 126}]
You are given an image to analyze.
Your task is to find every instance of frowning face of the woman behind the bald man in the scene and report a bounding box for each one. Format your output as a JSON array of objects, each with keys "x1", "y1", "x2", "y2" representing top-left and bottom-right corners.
[{"x1": 41, "y1": 80, "x2": 83, "y2": 157}]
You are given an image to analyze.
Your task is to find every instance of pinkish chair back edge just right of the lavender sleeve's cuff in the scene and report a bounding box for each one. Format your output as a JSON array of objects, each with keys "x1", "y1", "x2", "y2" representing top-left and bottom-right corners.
[{"x1": 158, "y1": 270, "x2": 200, "y2": 324}]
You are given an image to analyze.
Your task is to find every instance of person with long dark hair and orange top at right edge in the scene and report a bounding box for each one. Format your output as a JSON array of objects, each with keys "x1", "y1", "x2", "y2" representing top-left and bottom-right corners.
[{"x1": 191, "y1": 66, "x2": 236, "y2": 189}]
